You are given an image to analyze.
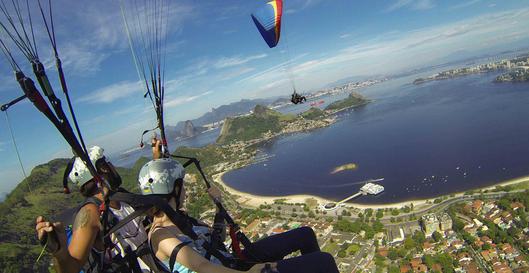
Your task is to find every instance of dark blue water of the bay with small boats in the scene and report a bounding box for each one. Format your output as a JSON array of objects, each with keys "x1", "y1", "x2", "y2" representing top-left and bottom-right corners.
[{"x1": 224, "y1": 73, "x2": 529, "y2": 203}]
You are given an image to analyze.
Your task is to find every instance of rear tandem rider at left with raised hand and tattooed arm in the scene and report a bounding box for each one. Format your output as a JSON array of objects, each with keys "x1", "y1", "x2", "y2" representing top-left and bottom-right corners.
[{"x1": 35, "y1": 146, "x2": 152, "y2": 273}]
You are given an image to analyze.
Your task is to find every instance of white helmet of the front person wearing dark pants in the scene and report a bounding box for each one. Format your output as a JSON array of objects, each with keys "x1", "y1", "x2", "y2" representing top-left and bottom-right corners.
[{"x1": 138, "y1": 158, "x2": 185, "y2": 195}]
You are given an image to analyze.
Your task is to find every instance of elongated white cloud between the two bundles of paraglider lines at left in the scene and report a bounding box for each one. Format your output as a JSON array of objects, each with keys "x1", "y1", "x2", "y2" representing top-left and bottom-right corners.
[{"x1": 78, "y1": 81, "x2": 143, "y2": 103}]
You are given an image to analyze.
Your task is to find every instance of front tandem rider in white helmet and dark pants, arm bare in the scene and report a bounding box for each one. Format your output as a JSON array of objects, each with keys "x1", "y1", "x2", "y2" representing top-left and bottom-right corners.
[{"x1": 139, "y1": 156, "x2": 338, "y2": 273}]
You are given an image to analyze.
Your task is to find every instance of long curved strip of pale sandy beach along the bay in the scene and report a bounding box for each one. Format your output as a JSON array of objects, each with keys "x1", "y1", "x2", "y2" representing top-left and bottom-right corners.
[{"x1": 213, "y1": 171, "x2": 529, "y2": 209}]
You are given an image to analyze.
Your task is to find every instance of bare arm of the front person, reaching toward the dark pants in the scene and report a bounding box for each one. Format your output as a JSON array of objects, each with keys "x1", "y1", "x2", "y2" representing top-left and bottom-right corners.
[{"x1": 151, "y1": 229, "x2": 264, "y2": 273}]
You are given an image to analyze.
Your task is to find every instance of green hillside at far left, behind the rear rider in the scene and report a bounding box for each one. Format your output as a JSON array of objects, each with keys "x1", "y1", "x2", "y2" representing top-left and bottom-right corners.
[{"x1": 0, "y1": 159, "x2": 82, "y2": 272}]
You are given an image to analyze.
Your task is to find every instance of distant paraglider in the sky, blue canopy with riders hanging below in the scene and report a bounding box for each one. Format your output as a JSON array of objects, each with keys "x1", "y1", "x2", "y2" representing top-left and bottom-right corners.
[{"x1": 252, "y1": 0, "x2": 307, "y2": 104}]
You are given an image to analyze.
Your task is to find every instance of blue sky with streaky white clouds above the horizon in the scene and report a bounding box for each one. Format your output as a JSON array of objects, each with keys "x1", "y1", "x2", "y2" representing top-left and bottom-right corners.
[{"x1": 0, "y1": 0, "x2": 529, "y2": 192}]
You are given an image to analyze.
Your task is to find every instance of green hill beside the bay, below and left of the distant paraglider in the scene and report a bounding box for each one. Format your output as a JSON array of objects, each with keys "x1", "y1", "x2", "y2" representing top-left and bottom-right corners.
[{"x1": 217, "y1": 105, "x2": 295, "y2": 144}]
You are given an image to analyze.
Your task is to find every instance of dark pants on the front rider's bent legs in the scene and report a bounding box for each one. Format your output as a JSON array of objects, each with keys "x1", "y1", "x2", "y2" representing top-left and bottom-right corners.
[{"x1": 244, "y1": 227, "x2": 338, "y2": 273}]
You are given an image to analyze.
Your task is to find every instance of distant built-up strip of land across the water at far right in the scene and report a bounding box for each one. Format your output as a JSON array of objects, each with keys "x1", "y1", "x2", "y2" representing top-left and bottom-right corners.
[{"x1": 413, "y1": 56, "x2": 529, "y2": 84}]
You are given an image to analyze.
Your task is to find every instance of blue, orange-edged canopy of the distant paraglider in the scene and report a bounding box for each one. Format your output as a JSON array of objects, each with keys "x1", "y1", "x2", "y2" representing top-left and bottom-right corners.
[{"x1": 252, "y1": 0, "x2": 283, "y2": 48}]
